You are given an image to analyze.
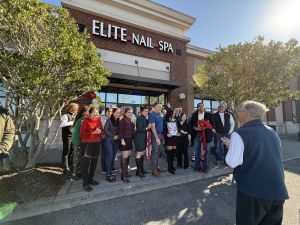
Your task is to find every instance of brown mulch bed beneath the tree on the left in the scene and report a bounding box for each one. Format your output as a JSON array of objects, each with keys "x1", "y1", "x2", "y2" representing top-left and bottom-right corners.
[{"x1": 0, "y1": 164, "x2": 69, "y2": 205}]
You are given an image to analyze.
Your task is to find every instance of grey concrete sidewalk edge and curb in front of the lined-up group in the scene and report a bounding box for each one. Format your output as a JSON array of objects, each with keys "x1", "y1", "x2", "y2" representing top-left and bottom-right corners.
[{"x1": 0, "y1": 167, "x2": 233, "y2": 224}]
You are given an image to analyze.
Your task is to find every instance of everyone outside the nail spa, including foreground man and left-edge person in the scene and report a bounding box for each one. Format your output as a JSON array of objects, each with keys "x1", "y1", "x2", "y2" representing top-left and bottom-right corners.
[{"x1": 0, "y1": 101, "x2": 289, "y2": 225}]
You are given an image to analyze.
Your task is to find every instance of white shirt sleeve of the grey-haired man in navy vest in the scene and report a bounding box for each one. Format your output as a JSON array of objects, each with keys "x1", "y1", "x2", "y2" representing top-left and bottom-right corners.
[{"x1": 225, "y1": 132, "x2": 244, "y2": 168}]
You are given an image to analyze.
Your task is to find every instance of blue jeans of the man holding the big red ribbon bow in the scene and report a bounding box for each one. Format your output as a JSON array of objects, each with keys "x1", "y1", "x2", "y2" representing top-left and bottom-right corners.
[{"x1": 194, "y1": 132, "x2": 210, "y2": 170}]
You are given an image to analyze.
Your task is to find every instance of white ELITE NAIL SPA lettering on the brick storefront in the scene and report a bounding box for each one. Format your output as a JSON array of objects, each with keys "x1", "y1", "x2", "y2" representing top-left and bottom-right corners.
[{"x1": 92, "y1": 20, "x2": 173, "y2": 53}]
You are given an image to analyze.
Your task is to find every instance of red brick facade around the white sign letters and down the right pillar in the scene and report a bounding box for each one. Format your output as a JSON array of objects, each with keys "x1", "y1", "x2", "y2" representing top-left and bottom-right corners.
[{"x1": 68, "y1": 8, "x2": 188, "y2": 110}]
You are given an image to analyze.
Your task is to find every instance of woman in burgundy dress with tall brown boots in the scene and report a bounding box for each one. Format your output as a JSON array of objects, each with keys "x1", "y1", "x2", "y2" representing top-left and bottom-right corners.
[{"x1": 118, "y1": 107, "x2": 135, "y2": 183}]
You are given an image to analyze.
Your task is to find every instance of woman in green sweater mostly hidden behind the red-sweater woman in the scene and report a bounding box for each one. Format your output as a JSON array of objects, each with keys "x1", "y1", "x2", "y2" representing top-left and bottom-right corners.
[{"x1": 72, "y1": 106, "x2": 88, "y2": 180}]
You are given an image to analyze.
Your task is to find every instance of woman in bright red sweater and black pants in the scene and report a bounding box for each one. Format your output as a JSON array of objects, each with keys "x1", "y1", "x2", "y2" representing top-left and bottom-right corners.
[{"x1": 80, "y1": 107, "x2": 104, "y2": 191}]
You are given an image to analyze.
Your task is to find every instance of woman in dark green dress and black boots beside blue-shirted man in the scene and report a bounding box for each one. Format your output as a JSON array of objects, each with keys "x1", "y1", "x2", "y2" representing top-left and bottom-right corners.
[{"x1": 134, "y1": 107, "x2": 150, "y2": 178}]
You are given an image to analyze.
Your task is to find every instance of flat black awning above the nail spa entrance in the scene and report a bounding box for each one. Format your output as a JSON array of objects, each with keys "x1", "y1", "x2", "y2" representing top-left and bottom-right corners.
[{"x1": 108, "y1": 73, "x2": 182, "y2": 90}]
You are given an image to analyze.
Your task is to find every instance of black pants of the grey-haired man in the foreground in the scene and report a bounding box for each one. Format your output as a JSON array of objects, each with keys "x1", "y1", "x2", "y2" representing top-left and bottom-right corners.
[{"x1": 236, "y1": 191, "x2": 284, "y2": 225}]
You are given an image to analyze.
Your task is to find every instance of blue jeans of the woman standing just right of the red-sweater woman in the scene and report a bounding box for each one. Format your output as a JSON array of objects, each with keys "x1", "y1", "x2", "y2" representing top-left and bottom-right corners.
[{"x1": 105, "y1": 138, "x2": 119, "y2": 175}]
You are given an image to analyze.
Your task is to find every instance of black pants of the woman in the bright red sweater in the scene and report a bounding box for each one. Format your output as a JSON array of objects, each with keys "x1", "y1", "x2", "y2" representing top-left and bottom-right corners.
[{"x1": 81, "y1": 142, "x2": 100, "y2": 185}]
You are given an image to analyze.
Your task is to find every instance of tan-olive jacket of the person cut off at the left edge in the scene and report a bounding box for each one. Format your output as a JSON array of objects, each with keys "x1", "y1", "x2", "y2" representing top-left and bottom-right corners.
[{"x1": 0, "y1": 106, "x2": 15, "y2": 154}]
